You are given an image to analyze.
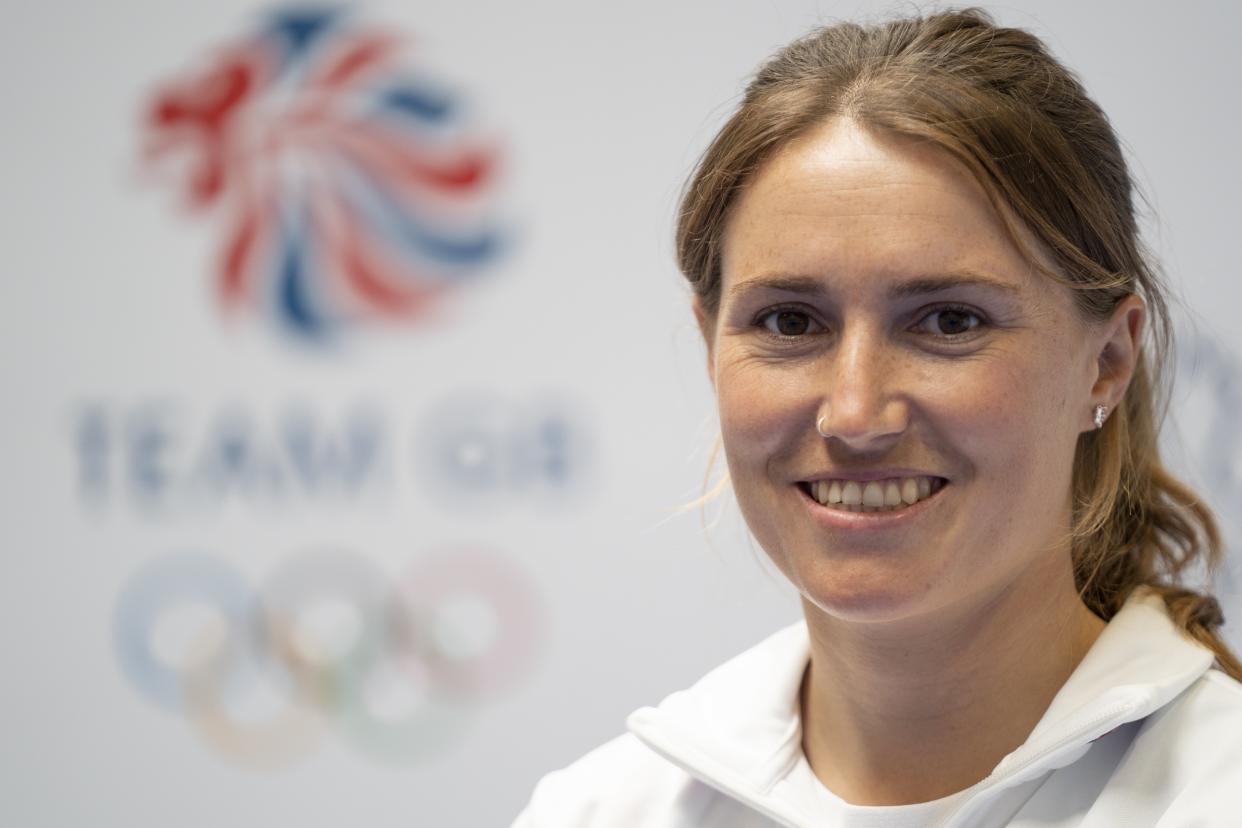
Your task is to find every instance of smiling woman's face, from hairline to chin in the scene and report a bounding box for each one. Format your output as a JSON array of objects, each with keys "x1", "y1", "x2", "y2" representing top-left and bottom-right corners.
[{"x1": 699, "y1": 120, "x2": 1110, "y2": 621}]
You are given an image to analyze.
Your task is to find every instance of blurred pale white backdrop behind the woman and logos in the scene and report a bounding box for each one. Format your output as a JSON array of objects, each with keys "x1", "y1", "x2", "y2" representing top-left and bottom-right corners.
[{"x1": 0, "y1": 0, "x2": 1242, "y2": 828}]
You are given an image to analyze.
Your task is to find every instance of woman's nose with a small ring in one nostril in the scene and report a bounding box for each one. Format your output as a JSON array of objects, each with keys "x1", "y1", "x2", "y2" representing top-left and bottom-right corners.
[{"x1": 815, "y1": 328, "x2": 909, "y2": 452}]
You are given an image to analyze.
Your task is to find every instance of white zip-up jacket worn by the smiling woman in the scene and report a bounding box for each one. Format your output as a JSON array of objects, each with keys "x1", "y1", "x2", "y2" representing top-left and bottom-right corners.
[{"x1": 513, "y1": 592, "x2": 1242, "y2": 828}]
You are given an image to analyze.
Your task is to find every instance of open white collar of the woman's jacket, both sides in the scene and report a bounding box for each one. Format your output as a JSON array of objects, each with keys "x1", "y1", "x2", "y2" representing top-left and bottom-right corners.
[{"x1": 626, "y1": 590, "x2": 1213, "y2": 818}]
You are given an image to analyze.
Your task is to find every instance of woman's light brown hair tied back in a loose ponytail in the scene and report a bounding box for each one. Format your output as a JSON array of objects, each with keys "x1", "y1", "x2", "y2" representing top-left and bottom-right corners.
[{"x1": 677, "y1": 9, "x2": 1242, "y2": 679}]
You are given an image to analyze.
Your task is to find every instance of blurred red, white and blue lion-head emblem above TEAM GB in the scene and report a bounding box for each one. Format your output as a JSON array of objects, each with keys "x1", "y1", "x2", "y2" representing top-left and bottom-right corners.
[{"x1": 144, "y1": 10, "x2": 507, "y2": 340}]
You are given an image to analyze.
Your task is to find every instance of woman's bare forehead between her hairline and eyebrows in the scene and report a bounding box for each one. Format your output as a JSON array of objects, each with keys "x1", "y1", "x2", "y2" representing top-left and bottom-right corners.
[{"x1": 722, "y1": 119, "x2": 1067, "y2": 306}]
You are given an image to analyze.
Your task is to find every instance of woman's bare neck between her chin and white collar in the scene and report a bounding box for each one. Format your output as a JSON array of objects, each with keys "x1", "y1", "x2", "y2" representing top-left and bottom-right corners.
[{"x1": 801, "y1": 566, "x2": 1104, "y2": 804}]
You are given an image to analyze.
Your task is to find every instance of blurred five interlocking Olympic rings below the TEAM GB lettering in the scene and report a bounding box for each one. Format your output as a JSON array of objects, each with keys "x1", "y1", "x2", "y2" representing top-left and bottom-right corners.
[{"x1": 113, "y1": 549, "x2": 544, "y2": 767}]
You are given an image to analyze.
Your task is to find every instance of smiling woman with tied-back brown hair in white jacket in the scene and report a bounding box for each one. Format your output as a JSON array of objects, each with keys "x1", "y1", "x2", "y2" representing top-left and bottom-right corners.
[{"x1": 515, "y1": 10, "x2": 1242, "y2": 828}]
